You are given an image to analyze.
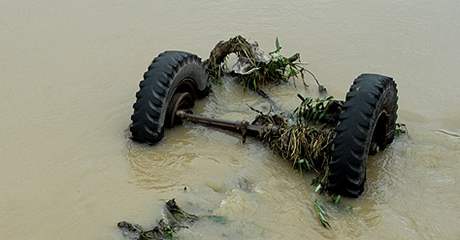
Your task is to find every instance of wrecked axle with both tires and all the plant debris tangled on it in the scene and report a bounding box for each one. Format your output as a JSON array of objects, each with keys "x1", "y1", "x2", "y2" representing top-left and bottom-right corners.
[{"x1": 125, "y1": 36, "x2": 402, "y2": 235}]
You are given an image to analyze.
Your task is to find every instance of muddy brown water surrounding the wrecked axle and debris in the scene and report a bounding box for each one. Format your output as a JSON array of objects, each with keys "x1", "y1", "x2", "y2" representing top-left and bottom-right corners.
[{"x1": 0, "y1": 0, "x2": 460, "y2": 240}]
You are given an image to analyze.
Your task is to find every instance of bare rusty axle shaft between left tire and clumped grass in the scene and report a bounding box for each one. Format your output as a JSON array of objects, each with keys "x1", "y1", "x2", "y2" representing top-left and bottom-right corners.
[{"x1": 176, "y1": 110, "x2": 277, "y2": 142}]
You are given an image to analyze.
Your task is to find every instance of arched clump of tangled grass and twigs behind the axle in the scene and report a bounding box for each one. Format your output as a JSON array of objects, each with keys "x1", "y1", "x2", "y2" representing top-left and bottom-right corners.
[{"x1": 205, "y1": 36, "x2": 326, "y2": 92}]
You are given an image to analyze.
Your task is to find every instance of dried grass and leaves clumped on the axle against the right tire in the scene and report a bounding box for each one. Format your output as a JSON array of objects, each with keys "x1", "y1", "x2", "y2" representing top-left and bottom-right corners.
[{"x1": 253, "y1": 95, "x2": 342, "y2": 188}]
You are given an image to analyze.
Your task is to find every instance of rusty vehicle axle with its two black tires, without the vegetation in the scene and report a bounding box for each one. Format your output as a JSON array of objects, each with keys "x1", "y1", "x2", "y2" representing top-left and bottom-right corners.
[{"x1": 130, "y1": 51, "x2": 398, "y2": 197}]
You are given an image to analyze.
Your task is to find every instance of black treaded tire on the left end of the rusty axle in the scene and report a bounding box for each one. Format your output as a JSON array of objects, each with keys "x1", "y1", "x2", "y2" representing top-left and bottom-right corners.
[{"x1": 130, "y1": 51, "x2": 210, "y2": 144}]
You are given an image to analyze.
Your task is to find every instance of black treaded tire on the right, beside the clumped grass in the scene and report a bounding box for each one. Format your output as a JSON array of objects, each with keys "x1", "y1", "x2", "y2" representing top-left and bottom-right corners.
[{"x1": 328, "y1": 74, "x2": 398, "y2": 197}]
